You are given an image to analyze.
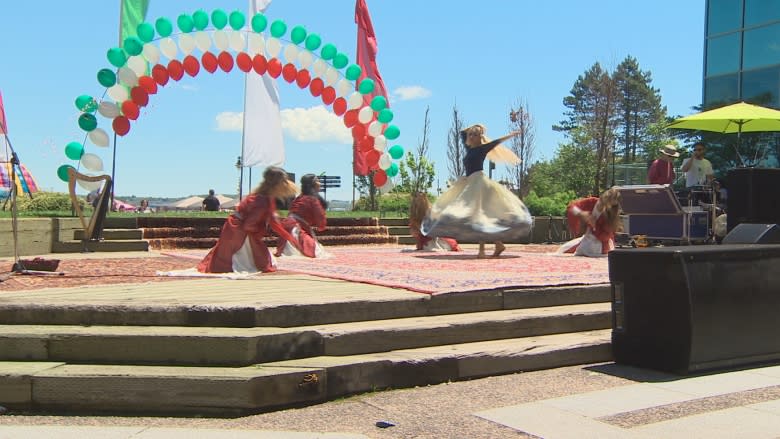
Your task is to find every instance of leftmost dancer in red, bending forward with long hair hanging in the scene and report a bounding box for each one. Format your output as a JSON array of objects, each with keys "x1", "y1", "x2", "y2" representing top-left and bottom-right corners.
[{"x1": 198, "y1": 167, "x2": 297, "y2": 273}]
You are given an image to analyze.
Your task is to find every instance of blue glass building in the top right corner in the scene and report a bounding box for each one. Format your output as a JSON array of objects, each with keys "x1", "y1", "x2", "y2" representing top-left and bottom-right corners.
[{"x1": 703, "y1": 0, "x2": 780, "y2": 109}]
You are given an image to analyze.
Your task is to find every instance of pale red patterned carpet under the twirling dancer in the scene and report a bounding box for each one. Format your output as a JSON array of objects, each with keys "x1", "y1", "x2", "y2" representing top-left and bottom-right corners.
[{"x1": 167, "y1": 246, "x2": 609, "y2": 294}]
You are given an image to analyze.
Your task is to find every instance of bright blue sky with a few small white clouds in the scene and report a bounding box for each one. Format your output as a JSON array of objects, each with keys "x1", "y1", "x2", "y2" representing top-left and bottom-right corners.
[{"x1": 0, "y1": 0, "x2": 704, "y2": 200}]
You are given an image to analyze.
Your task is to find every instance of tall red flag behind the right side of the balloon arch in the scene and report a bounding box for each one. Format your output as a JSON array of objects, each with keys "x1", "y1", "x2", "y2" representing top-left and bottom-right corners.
[{"x1": 352, "y1": 0, "x2": 390, "y2": 175}]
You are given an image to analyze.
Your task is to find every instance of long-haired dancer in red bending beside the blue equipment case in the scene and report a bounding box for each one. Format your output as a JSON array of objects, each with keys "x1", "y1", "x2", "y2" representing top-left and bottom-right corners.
[{"x1": 558, "y1": 189, "x2": 621, "y2": 257}]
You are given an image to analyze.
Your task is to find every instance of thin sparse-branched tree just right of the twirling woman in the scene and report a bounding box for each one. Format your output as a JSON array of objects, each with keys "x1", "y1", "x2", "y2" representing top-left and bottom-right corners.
[{"x1": 507, "y1": 102, "x2": 536, "y2": 196}]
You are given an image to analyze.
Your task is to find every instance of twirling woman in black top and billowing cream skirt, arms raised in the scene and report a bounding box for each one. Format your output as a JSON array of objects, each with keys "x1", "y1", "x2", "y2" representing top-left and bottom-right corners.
[{"x1": 421, "y1": 124, "x2": 532, "y2": 258}]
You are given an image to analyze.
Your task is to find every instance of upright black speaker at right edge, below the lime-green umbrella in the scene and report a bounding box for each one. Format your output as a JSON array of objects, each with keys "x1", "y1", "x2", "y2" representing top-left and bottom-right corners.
[{"x1": 726, "y1": 168, "x2": 780, "y2": 231}]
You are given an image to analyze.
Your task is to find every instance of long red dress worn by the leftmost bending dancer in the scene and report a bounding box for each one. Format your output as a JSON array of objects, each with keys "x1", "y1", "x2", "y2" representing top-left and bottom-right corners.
[{"x1": 198, "y1": 194, "x2": 287, "y2": 273}]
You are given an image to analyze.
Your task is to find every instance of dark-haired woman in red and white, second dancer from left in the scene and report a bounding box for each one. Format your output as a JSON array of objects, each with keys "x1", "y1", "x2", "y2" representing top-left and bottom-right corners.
[{"x1": 276, "y1": 174, "x2": 327, "y2": 258}]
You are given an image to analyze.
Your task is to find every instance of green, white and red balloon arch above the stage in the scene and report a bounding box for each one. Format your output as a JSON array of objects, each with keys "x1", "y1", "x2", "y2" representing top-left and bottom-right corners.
[{"x1": 57, "y1": 9, "x2": 404, "y2": 189}]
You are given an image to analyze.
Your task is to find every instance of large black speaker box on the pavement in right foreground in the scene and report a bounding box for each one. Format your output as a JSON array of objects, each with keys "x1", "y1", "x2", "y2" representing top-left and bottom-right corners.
[{"x1": 609, "y1": 244, "x2": 780, "y2": 374}]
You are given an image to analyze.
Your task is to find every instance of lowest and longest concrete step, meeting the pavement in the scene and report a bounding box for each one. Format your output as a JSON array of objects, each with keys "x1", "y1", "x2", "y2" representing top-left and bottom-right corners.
[{"x1": 0, "y1": 330, "x2": 612, "y2": 416}]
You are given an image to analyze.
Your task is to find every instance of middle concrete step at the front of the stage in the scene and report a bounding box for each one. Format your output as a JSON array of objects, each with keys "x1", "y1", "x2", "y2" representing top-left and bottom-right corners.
[{"x1": 0, "y1": 303, "x2": 612, "y2": 366}]
